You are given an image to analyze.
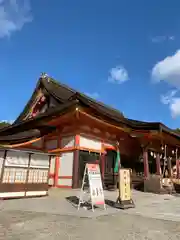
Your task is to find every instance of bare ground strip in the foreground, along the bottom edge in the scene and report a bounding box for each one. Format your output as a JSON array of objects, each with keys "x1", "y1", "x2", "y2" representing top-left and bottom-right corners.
[{"x1": 0, "y1": 207, "x2": 180, "y2": 240}]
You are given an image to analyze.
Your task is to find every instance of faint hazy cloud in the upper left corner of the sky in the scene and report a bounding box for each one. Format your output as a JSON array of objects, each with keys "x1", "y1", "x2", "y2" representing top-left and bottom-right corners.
[{"x1": 0, "y1": 0, "x2": 32, "y2": 38}]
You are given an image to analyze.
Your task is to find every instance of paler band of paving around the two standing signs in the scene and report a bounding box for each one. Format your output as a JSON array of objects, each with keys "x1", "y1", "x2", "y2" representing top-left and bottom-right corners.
[{"x1": 0, "y1": 189, "x2": 180, "y2": 222}]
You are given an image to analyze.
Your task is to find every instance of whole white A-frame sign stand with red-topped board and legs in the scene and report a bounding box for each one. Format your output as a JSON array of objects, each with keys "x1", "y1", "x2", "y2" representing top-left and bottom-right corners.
[{"x1": 78, "y1": 163, "x2": 106, "y2": 212}]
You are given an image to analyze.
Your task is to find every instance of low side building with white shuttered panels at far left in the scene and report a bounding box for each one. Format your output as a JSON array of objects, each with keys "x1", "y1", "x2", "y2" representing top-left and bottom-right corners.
[{"x1": 0, "y1": 148, "x2": 53, "y2": 199}]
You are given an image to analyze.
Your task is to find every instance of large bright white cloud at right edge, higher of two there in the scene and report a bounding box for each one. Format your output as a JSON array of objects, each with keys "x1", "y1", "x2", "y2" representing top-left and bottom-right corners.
[{"x1": 152, "y1": 50, "x2": 180, "y2": 88}]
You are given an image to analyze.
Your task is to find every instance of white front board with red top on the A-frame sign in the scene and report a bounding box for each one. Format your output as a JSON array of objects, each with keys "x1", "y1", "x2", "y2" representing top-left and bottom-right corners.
[{"x1": 86, "y1": 164, "x2": 105, "y2": 205}]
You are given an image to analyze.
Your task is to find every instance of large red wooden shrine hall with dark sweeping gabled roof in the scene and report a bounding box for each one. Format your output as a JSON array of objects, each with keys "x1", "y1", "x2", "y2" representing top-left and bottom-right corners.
[{"x1": 0, "y1": 74, "x2": 180, "y2": 195}]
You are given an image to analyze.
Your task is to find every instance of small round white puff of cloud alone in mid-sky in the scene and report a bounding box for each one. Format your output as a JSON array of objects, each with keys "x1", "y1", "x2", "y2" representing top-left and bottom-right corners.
[{"x1": 108, "y1": 66, "x2": 129, "y2": 83}]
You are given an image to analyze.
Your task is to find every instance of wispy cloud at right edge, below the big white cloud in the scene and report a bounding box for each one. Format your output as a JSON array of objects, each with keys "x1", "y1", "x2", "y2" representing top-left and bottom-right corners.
[{"x1": 161, "y1": 90, "x2": 180, "y2": 118}]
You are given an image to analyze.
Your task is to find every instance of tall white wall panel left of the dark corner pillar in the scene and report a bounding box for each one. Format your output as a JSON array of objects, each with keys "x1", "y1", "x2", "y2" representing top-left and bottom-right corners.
[{"x1": 58, "y1": 152, "x2": 74, "y2": 177}]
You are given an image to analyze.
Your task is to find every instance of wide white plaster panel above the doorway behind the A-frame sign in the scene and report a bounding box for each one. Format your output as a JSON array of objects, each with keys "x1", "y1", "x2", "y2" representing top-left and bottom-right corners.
[{"x1": 79, "y1": 136, "x2": 102, "y2": 151}]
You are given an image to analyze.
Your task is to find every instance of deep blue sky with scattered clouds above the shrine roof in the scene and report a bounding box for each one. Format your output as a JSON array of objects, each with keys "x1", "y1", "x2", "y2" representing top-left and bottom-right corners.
[{"x1": 0, "y1": 0, "x2": 180, "y2": 128}]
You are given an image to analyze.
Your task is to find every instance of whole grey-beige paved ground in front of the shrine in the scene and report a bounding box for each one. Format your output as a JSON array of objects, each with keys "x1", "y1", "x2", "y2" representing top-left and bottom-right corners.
[{"x1": 0, "y1": 191, "x2": 180, "y2": 240}]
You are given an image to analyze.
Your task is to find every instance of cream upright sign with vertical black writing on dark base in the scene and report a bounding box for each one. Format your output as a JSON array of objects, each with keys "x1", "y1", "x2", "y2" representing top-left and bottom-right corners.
[{"x1": 115, "y1": 168, "x2": 135, "y2": 209}]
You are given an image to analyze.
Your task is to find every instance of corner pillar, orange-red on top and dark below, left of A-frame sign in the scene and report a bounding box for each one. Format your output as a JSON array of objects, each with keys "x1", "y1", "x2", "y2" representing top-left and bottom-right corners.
[{"x1": 72, "y1": 135, "x2": 80, "y2": 188}]
